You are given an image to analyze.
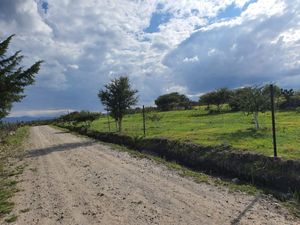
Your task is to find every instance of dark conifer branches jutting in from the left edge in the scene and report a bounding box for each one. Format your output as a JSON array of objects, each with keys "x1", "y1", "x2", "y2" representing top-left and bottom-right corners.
[{"x1": 0, "y1": 35, "x2": 42, "y2": 120}]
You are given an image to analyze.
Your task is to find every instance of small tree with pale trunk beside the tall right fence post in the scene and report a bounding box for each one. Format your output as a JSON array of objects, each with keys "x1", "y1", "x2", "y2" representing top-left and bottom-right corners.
[{"x1": 239, "y1": 87, "x2": 270, "y2": 130}]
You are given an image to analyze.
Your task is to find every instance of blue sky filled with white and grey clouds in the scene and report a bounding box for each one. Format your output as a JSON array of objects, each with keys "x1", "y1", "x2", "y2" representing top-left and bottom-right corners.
[{"x1": 0, "y1": 0, "x2": 300, "y2": 116}]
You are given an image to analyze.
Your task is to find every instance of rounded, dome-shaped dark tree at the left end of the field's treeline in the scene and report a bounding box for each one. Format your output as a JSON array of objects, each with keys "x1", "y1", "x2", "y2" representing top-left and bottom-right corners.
[{"x1": 155, "y1": 92, "x2": 191, "y2": 111}]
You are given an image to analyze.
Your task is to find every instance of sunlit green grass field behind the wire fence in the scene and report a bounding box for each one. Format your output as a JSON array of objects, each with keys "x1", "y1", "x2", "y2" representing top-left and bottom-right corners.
[{"x1": 91, "y1": 108, "x2": 300, "y2": 159}]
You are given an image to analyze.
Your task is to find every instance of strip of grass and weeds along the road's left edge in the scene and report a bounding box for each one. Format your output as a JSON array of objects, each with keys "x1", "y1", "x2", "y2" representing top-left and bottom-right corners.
[{"x1": 0, "y1": 125, "x2": 28, "y2": 222}]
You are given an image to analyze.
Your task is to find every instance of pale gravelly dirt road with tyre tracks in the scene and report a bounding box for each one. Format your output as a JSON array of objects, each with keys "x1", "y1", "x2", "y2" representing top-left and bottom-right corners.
[{"x1": 2, "y1": 126, "x2": 299, "y2": 225}]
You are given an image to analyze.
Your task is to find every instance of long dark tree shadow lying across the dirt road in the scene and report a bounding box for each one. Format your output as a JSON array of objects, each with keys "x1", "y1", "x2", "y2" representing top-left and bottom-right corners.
[{"x1": 28, "y1": 141, "x2": 96, "y2": 157}]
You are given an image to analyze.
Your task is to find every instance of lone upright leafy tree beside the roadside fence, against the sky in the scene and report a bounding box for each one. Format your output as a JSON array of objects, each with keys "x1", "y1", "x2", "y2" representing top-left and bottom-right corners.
[{"x1": 98, "y1": 76, "x2": 137, "y2": 132}]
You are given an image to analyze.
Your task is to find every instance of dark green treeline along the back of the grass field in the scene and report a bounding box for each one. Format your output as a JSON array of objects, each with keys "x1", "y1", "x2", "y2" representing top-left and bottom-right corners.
[{"x1": 151, "y1": 85, "x2": 300, "y2": 112}]
